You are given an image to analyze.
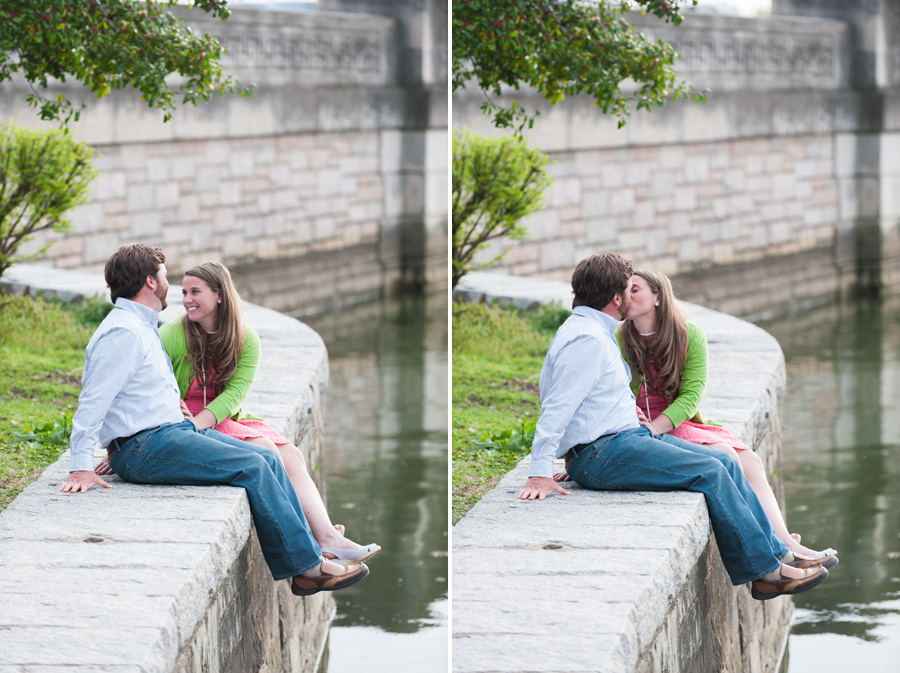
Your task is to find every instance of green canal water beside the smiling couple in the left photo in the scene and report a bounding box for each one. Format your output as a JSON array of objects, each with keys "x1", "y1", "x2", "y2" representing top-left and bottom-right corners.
[{"x1": 304, "y1": 292, "x2": 449, "y2": 673}]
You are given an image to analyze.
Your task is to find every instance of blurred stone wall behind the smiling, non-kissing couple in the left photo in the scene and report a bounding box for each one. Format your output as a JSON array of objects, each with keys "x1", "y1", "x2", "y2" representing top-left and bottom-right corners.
[{"x1": 0, "y1": 2, "x2": 448, "y2": 312}]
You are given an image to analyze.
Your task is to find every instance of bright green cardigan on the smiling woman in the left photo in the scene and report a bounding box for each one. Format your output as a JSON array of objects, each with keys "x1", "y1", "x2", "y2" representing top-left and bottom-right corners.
[{"x1": 159, "y1": 318, "x2": 260, "y2": 423}]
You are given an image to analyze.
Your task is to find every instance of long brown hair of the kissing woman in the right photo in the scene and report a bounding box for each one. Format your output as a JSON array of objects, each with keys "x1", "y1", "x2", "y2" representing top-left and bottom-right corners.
[{"x1": 622, "y1": 269, "x2": 688, "y2": 403}]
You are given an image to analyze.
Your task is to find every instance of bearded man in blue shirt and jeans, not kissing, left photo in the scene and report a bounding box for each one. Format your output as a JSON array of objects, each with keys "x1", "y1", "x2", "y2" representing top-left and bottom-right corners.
[{"x1": 59, "y1": 243, "x2": 369, "y2": 596}]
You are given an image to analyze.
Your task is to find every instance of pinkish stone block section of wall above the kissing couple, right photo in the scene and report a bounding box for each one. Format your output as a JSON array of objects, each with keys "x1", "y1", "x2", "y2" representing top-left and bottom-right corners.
[{"x1": 482, "y1": 134, "x2": 840, "y2": 308}]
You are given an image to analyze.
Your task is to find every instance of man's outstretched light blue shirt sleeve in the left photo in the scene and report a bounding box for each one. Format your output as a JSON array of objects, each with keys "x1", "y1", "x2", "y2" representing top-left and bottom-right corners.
[{"x1": 69, "y1": 328, "x2": 144, "y2": 472}]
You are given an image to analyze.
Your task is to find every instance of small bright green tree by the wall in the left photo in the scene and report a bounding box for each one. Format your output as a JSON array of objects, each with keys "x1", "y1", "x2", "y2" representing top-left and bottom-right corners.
[{"x1": 0, "y1": 124, "x2": 97, "y2": 276}]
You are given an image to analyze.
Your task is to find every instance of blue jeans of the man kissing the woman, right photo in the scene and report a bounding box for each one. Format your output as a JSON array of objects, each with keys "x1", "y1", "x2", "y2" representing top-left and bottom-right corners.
[{"x1": 568, "y1": 427, "x2": 788, "y2": 586}]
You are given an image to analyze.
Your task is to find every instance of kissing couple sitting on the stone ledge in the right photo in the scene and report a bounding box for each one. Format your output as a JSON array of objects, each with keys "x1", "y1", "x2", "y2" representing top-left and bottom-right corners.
[{"x1": 518, "y1": 254, "x2": 838, "y2": 600}]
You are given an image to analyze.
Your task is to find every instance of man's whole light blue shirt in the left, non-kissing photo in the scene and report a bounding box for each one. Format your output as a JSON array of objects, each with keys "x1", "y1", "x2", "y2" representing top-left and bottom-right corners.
[{"x1": 69, "y1": 297, "x2": 184, "y2": 471}]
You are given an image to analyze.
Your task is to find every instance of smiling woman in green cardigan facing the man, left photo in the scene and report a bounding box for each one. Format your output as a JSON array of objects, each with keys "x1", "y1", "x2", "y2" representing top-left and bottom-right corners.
[{"x1": 126, "y1": 262, "x2": 381, "y2": 565}]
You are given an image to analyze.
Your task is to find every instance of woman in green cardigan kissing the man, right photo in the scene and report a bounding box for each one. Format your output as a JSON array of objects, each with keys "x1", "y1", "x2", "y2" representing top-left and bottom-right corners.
[{"x1": 556, "y1": 271, "x2": 837, "y2": 567}]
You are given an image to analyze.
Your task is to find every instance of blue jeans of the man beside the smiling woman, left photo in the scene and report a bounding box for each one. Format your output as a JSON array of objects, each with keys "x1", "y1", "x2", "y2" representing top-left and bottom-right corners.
[{"x1": 110, "y1": 421, "x2": 322, "y2": 580}]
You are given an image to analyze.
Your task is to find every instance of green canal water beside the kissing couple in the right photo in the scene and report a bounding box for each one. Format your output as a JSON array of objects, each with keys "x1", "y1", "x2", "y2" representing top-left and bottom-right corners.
[{"x1": 760, "y1": 296, "x2": 900, "y2": 673}]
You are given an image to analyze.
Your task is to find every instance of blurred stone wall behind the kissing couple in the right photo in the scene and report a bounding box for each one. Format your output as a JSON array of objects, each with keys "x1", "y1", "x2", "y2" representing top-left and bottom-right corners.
[{"x1": 453, "y1": 5, "x2": 900, "y2": 315}]
